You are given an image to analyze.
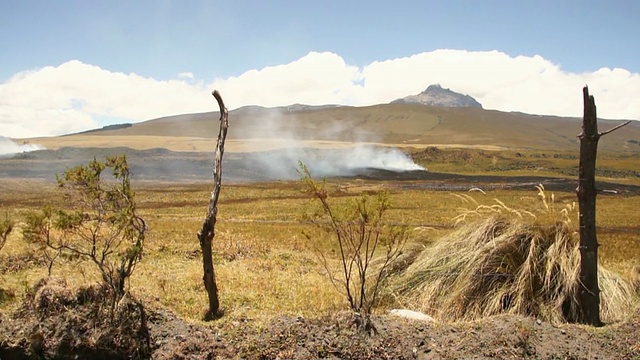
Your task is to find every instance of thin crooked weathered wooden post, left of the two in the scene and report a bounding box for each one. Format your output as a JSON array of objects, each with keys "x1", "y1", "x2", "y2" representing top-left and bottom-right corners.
[{"x1": 198, "y1": 90, "x2": 229, "y2": 320}]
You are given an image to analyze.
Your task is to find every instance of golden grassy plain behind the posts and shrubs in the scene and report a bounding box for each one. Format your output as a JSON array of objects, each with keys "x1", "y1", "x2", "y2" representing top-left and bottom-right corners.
[{"x1": 0, "y1": 170, "x2": 640, "y2": 323}]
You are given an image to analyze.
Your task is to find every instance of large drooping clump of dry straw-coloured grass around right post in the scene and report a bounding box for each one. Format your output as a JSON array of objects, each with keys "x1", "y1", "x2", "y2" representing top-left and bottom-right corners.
[{"x1": 392, "y1": 186, "x2": 636, "y2": 323}]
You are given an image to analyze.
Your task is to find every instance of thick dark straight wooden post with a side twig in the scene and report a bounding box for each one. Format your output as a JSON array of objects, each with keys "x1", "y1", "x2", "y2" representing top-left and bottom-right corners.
[{"x1": 576, "y1": 86, "x2": 629, "y2": 326}]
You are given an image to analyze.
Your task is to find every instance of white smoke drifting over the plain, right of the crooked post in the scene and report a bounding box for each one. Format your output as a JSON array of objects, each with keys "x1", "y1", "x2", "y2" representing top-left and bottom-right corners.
[{"x1": 243, "y1": 110, "x2": 426, "y2": 179}]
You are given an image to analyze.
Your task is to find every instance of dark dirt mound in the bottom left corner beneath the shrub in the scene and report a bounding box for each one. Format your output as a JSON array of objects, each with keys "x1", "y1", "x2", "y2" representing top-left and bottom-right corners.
[{"x1": 0, "y1": 278, "x2": 150, "y2": 359}]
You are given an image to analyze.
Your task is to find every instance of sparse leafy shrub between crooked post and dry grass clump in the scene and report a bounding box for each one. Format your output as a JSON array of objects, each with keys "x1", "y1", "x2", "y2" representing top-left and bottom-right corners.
[{"x1": 300, "y1": 164, "x2": 407, "y2": 331}]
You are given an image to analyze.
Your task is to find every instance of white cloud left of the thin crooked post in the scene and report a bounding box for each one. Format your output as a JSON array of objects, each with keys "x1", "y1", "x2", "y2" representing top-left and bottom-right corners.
[{"x1": 0, "y1": 60, "x2": 212, "y2": 138}]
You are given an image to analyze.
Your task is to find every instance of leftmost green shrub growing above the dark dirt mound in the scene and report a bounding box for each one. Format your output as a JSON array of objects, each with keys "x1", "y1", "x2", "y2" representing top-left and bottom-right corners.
[{"x1": 24, "y1": 156, "x2": 147, "y2": 308}]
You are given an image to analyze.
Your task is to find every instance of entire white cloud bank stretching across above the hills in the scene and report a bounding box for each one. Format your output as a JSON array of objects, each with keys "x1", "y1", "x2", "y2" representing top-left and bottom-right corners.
[{"x1": 0, "y1": 50, "x2": 640, "y2": 138}]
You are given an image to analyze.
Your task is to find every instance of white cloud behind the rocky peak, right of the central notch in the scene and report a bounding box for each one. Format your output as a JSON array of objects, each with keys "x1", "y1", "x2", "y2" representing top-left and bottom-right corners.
[{"x1": 363, "y1": 50, "x2": 640, "y2": 119}]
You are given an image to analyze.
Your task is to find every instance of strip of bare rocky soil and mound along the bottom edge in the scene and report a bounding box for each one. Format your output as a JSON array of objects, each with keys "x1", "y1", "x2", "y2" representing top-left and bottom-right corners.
[{"x1": 0, "y1": 280, "x2": 640, "y2": 360}]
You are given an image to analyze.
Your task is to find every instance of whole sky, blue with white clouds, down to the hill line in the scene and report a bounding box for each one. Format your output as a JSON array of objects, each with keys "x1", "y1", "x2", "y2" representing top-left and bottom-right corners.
[{"x1": 0, "y1": 0, "x2": 640, "y2": 137}]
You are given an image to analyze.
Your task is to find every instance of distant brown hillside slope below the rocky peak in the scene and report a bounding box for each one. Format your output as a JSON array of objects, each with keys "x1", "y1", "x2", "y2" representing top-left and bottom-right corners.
[{"x1": 77, "y1": 103, "x2": 640, "y2": 152}]
